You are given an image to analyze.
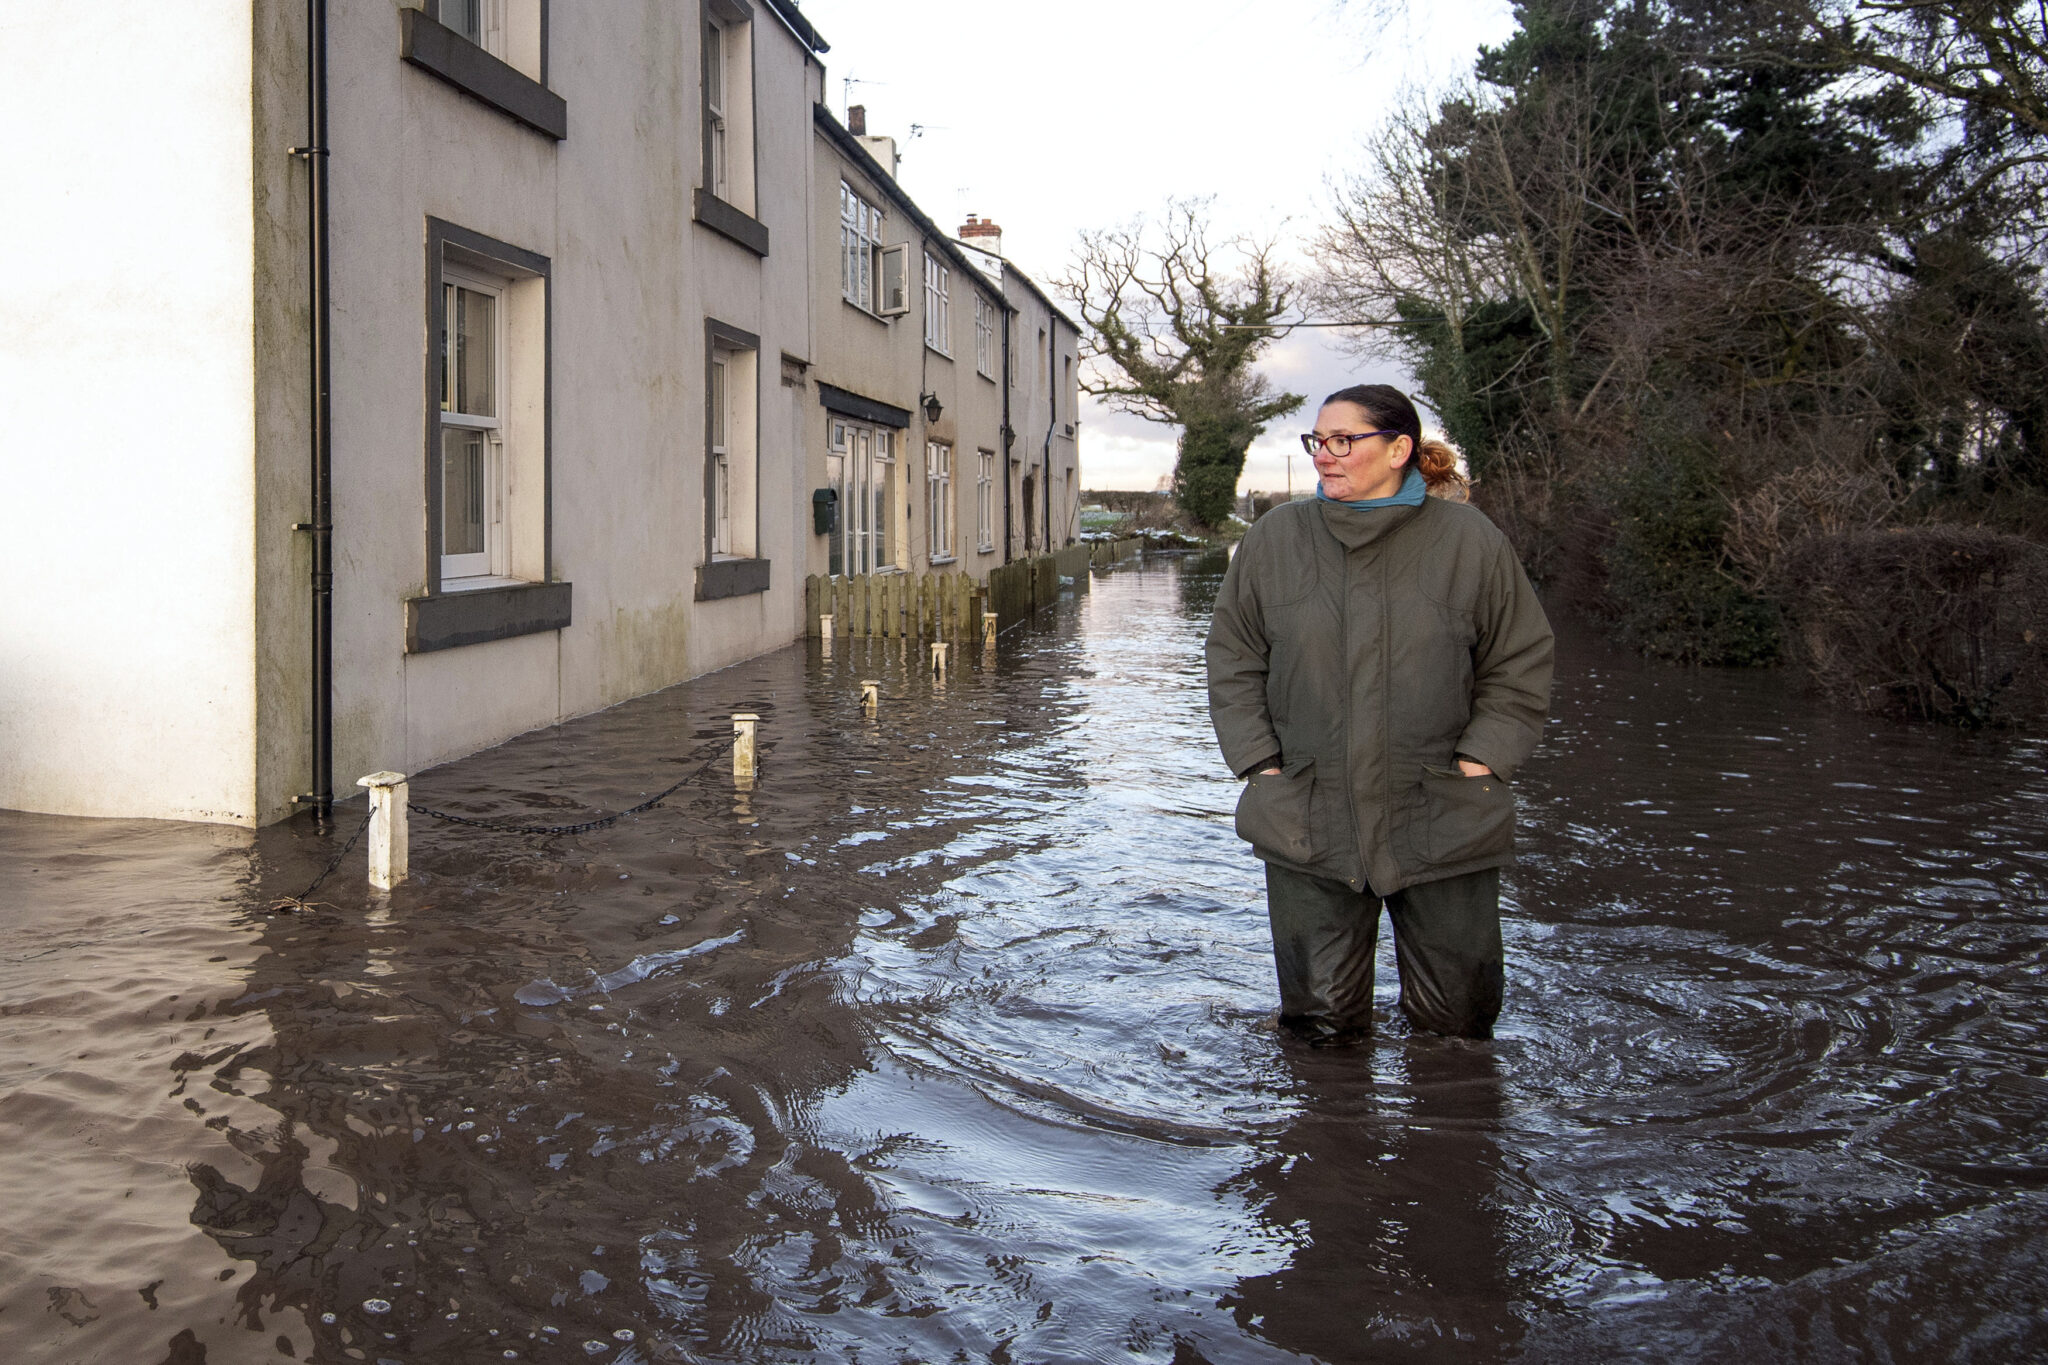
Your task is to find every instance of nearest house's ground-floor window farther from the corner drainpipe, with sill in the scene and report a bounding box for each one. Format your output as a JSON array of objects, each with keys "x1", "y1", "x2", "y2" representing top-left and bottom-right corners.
[{"x1": 696, "y1": 319, "x2": 768, "y2": 600}]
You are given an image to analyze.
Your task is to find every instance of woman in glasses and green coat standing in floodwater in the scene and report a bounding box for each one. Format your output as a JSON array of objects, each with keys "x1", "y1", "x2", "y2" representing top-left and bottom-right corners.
[{"x1": 1208, "y1": 385, "x2": 1550, "y2": 1042}]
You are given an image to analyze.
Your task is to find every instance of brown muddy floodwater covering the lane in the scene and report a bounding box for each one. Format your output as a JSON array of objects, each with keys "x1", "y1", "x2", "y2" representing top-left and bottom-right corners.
[{"x1": 0, "y1": 561, "x2": 2048, "y2": 1365}]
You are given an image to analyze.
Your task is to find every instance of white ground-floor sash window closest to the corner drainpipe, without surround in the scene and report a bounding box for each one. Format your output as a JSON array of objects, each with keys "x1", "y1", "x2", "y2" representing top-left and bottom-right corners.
[{"x1": 440, "y1": 270, "x2": 508, "y2": 583}]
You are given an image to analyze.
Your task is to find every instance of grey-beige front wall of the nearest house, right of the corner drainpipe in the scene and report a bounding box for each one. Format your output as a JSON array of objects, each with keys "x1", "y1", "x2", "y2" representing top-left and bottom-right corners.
[{"x1": 280, "y1": 0, "x2": 817, "y2": 817}]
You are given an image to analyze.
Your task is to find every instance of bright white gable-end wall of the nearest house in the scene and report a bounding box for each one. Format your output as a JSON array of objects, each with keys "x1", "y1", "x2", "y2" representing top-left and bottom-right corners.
[{"x1": 0, "y1": 4, "x2": 264, "y2": 825}]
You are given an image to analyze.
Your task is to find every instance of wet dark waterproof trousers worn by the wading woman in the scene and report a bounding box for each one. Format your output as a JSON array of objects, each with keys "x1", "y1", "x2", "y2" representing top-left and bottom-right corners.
[{"x1": 1266, "y1": 864, "x2": 1503, "y2": 1042}]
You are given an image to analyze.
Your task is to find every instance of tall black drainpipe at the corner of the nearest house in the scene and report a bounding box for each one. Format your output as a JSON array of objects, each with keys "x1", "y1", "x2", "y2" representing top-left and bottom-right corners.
[{"x1": 293, "y1": 0, "x2": 334, "y2": 823}]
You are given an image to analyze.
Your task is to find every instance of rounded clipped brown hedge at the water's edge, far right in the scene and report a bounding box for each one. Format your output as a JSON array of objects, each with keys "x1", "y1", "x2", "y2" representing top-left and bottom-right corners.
[{"x1": 1776, "y1": 526, "x2": 2048, "y2": 729}]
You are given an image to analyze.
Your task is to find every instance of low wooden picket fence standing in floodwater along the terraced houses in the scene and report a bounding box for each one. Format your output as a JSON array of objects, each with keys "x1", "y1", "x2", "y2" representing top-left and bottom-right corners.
[{"x1": 803, "y1": 540, "x2": 1143, "y2": 641}]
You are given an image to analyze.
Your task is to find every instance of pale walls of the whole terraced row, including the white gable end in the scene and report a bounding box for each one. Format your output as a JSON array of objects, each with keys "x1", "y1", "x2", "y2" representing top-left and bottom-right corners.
[{"x1": 0, "y1": 0, "x2": 1071, "y2": 825}]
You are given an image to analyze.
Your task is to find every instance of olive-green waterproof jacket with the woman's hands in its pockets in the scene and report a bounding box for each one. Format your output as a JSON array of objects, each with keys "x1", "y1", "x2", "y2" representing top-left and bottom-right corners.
[{"x1": 1208, "y1": 497, "x2": 1552, "y2": 896}]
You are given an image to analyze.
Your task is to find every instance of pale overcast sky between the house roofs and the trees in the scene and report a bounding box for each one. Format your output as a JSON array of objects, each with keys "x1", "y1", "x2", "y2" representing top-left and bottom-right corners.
[{"x1": 803, "y1": 0, "x2": 1513, "y2": 489}]
